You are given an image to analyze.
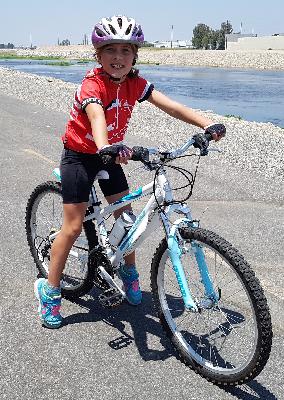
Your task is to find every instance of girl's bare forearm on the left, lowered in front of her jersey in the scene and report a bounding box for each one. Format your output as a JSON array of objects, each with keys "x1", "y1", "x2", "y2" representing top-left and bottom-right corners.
[{"x1": 86, "y1": 103, "x2": 109, "y2": 149}]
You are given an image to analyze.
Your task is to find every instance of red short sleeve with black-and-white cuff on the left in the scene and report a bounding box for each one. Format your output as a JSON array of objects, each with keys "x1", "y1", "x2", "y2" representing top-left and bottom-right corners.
[{"x1": 78, "y1": 75, "x2": 103, "y2": 111}]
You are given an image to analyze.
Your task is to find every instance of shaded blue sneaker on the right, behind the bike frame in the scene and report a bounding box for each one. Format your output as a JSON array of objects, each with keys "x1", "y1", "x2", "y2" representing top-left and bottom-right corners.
[{"x1": 118, "y1": 265, "x2": 142, "y2": 306}]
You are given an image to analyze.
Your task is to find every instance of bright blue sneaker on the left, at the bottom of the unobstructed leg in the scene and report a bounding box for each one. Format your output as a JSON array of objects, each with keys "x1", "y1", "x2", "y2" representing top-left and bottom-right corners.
[{"x1": 34, "y1": 278, "x2": 62, "y2": 328}]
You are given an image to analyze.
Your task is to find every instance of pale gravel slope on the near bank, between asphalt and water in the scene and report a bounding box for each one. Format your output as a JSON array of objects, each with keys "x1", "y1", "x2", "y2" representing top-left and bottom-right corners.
[{"x1": 0, "y1": 68, "x2": 284, "y2": 204}]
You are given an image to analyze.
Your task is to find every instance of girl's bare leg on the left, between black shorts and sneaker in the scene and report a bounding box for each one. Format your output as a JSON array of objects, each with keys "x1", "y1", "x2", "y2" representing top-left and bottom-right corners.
[{"x1": 48, "y1": 203, "x2": 88, "y2": 287}]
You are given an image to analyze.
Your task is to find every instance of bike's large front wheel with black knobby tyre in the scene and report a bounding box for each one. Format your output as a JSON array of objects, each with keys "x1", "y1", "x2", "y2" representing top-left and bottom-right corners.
[{"x1": 151, "y1": 228, "x2": 272, "y2": 386}]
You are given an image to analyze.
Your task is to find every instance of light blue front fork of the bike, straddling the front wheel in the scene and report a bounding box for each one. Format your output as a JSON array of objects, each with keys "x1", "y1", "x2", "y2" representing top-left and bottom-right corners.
[{"x1": 168, "y1": 219, "x2": 219, "y2": 312}]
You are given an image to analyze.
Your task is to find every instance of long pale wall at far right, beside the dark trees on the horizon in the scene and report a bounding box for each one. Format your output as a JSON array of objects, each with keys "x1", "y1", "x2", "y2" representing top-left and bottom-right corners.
[{"x1": 227, "y1": 35, "x2": 284, "y2": 51}]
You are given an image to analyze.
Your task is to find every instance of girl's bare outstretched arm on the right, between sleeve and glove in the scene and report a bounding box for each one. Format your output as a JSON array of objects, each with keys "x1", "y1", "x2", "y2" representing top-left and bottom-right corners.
[{"x1": 148, "y1": 89, "x2": 214, "y2": 129}]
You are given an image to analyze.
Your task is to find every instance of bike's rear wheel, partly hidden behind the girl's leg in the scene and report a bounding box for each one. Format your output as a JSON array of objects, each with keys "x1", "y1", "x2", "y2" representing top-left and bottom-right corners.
[{"x1": 26, "y1": 181, "x2": 95, "y2": 298}]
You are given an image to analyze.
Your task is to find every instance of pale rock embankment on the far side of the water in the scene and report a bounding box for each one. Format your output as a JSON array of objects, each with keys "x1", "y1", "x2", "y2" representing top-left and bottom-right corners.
[{"x1": 3, "y1": 45, "x2": 284, "y2": 70}]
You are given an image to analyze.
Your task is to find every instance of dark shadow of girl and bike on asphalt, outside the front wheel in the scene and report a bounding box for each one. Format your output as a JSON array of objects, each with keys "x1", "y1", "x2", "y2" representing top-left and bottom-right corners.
[{"x1": 64, "y1": 291, "x2": 277, "y2": 400}]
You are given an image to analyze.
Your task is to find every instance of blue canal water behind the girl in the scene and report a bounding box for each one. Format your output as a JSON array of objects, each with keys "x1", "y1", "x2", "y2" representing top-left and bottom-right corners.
[{"x1": 0, "y1": 60, "x2": 284, "y2": 127}]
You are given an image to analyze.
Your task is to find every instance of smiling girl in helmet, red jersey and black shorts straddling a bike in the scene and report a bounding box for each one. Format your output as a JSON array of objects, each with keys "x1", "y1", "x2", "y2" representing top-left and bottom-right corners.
[{"x1": 35, "y1": 16, "x2": 226, "y2": 328}]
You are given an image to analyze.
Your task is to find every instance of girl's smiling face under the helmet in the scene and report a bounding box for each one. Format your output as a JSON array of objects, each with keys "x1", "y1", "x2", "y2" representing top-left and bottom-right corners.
[{"x1": 97, "y1": 43, "x2": 135, "y2": 82}]
